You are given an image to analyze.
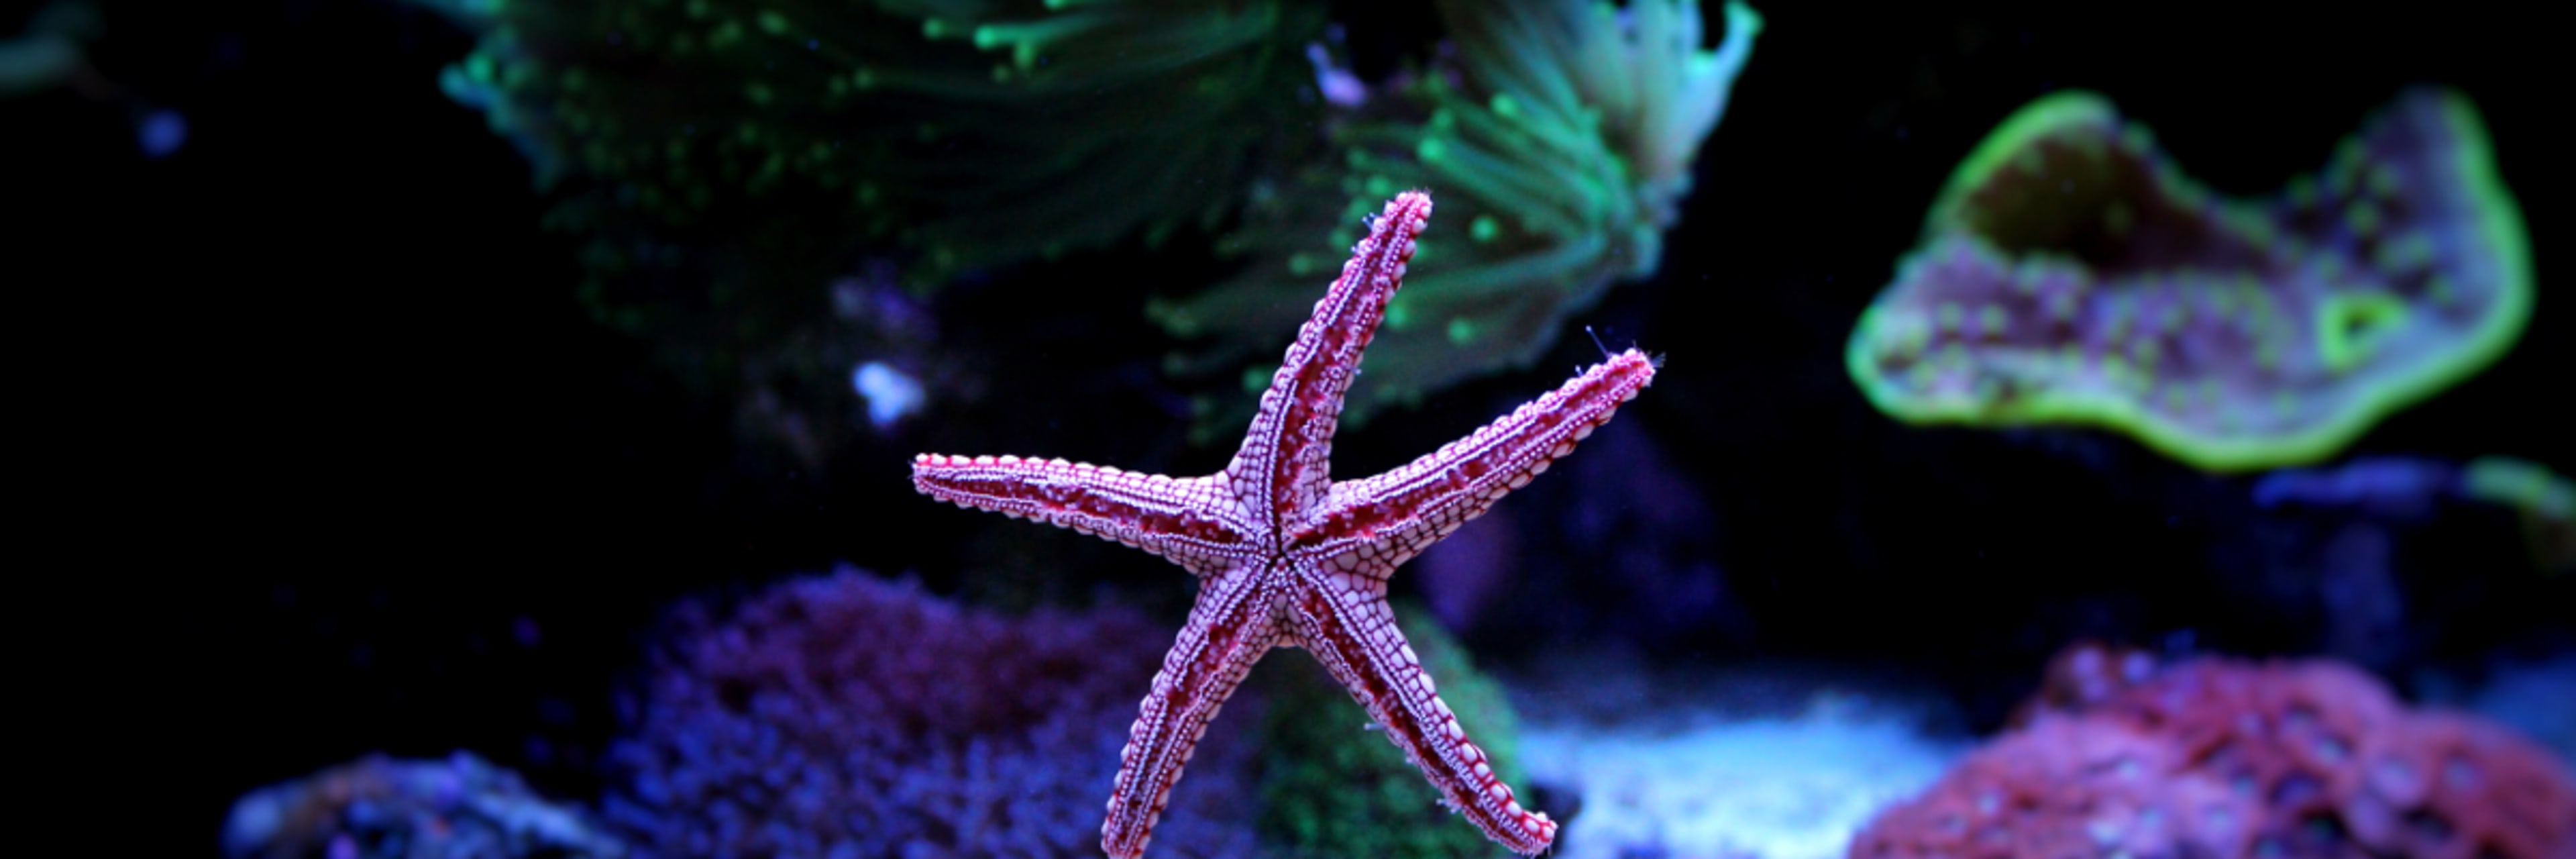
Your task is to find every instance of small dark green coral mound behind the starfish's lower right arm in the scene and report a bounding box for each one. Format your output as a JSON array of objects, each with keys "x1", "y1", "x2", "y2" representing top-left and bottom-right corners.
[{"x1": 1260, "y1": 603, "x2": 1522, "y2": 859}]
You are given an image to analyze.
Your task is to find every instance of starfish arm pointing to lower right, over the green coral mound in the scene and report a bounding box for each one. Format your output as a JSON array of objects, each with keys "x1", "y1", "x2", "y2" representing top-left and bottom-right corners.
[{"x1": 1291, "y1": 575, "x2": 1556, "y2": 854}]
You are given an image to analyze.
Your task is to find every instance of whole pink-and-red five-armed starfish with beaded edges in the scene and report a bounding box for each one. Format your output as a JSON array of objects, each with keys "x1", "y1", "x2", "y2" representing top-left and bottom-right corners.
[{"x1": 912, "y1": 191, "x2": 1656, "y2": 859}]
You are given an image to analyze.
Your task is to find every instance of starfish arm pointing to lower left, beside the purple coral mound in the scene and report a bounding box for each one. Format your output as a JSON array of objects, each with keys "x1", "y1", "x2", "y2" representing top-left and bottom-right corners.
[{"x1": 1100, "y1": 570, "x2": 1288, "y2": 859}]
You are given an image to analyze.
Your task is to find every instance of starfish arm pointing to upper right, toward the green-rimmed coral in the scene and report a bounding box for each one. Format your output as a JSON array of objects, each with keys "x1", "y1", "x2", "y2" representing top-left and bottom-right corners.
[{"x1": 1288, "y1": 348, "x2": 1656, "y2": 567}]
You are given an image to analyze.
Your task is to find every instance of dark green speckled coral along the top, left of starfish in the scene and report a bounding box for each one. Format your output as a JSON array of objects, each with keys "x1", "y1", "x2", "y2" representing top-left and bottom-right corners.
[{"x1": 417, "y1": 0, "x2": 1324, "y2": 379}]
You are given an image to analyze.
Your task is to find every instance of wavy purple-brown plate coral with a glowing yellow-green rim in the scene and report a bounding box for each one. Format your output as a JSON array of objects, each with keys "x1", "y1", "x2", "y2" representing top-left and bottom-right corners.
[{"x1": 1847, "y1": 91, "x2": 2532, "y2": 470}]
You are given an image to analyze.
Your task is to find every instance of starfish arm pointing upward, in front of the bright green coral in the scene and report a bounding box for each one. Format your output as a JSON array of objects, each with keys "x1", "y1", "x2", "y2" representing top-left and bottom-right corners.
[{"x1": 1226, "y1": 191, "x2": 1432, "y2": 526}]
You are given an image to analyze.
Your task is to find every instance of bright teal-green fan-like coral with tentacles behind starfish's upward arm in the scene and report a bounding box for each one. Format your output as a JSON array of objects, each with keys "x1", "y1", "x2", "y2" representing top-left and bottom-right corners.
[{"x1": 1151, "y1": 0, "x2": 1762, "y2": 425}]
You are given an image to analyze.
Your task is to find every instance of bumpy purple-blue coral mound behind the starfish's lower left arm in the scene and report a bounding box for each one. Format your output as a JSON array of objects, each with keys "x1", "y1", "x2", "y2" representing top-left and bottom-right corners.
[{"x1": 608, "y1": 568, "x2": 1252, "y2": 859}]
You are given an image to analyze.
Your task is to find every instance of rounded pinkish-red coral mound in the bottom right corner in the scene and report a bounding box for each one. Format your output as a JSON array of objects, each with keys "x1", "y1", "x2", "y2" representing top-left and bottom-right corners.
[{"x1": 1849, "y1": 660, "x2": 2576, "y2": 859}]
